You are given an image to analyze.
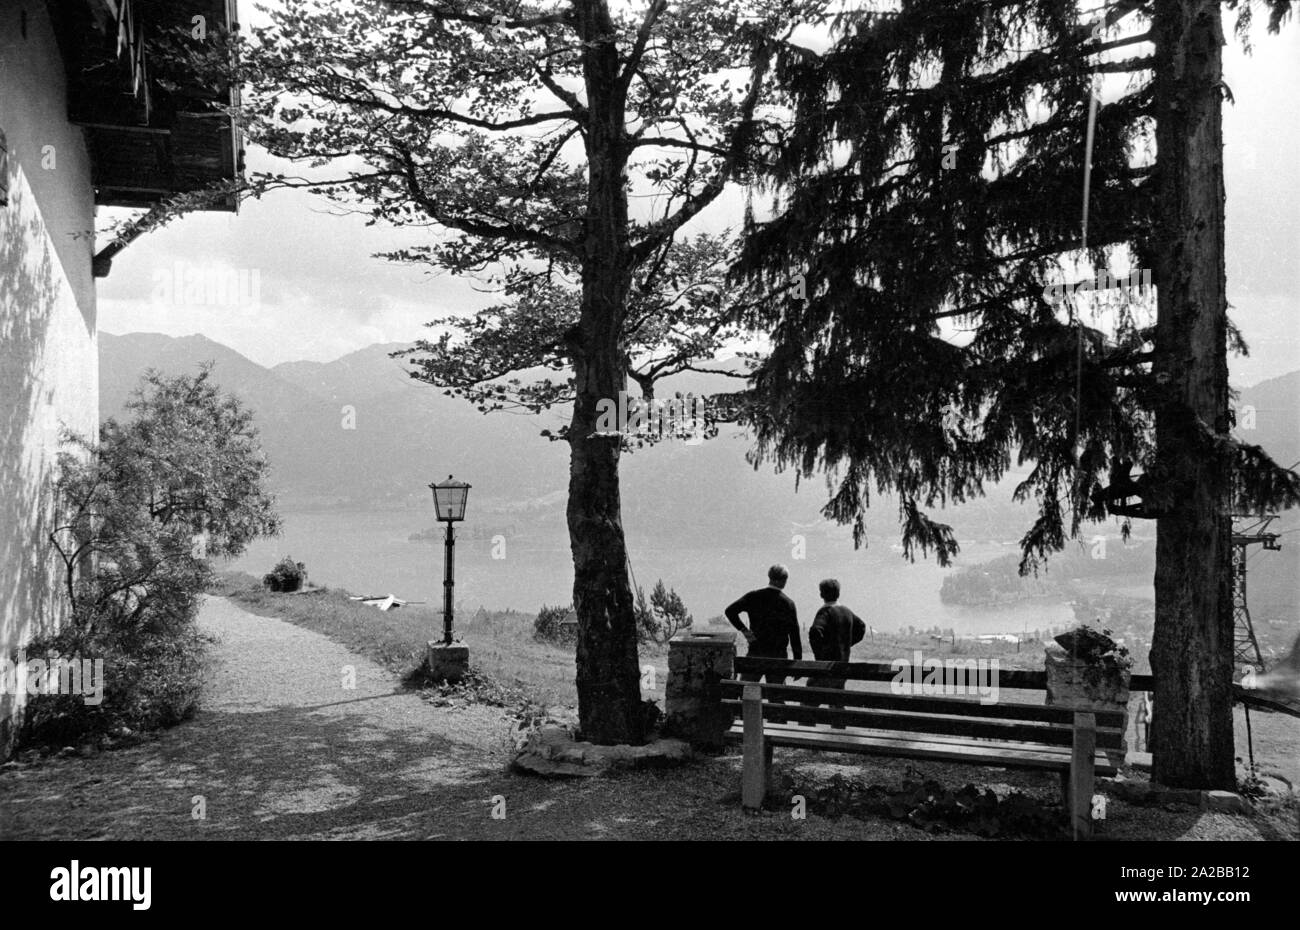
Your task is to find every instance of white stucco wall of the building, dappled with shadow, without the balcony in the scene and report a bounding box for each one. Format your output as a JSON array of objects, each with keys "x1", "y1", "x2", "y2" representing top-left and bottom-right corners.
[{"x1": 0, "y1": 0, "x2": 99, "y2": 758}]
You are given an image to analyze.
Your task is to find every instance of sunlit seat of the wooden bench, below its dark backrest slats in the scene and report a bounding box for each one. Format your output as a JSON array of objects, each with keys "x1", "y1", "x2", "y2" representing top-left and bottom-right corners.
[{"x1": 728, "y1": 724, "x2": 1118, "y2": 775}]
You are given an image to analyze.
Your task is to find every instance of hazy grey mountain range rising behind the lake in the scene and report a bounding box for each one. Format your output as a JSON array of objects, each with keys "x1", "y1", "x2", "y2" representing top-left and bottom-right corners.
[{"x1": 100, "y1": 333, "x2": 1300, "y2": 556}]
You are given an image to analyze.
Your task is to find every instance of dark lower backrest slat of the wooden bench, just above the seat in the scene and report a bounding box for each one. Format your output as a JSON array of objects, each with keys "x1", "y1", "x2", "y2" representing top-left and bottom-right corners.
[{"x1": 722, "y1": 692, "x2": 1121, "y2": 748}]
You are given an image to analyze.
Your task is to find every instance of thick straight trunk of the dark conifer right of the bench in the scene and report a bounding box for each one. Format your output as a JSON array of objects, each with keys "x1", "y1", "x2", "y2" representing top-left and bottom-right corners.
[{"x1": 1151, "y1": 0, "x2": 1235, "y2": 788}]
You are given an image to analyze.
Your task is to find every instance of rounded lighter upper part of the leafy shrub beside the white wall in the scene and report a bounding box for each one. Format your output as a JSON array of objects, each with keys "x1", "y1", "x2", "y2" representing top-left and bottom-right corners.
[{"x1": 51, "y1": 368, "x2": 280, "y2": 632}]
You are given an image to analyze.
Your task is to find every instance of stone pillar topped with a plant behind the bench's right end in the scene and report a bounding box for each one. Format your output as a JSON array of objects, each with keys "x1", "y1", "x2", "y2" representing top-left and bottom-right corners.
[{"x1": 1045, "y1": 627, "x2": 1132, "y2": 752}]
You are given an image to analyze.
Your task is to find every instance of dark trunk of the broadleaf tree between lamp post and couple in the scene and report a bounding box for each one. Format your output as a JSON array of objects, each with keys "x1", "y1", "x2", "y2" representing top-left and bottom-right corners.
[{"x1": 568, "y1": 0, "x2": 645, "y2": 743}]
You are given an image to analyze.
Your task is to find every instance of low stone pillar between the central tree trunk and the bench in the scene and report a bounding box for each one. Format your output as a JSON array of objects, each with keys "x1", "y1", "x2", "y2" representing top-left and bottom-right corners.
[{"x1": 664, "y1": 631, "x2": 736, "y2": 752}]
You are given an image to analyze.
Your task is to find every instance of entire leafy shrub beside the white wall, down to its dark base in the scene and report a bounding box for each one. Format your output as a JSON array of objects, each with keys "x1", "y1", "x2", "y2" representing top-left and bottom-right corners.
[{"x1": 25, "y1": 368, "x2": 280, "y2": 743}]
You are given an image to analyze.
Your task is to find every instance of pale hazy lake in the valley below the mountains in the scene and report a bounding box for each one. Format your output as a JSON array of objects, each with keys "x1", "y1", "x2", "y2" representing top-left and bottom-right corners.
[{"x1": 228, "y1": 507, "x2": 1074, "y2": 635}]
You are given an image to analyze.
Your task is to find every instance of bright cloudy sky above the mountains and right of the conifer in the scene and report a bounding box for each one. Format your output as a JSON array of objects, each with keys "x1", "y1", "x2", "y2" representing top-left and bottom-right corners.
[{"x1": 99, "y1": 0, "x2": 1300, "y2": 386}]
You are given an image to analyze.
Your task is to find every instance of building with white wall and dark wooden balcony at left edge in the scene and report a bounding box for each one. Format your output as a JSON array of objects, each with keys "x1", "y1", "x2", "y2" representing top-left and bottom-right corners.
[{"x1": 0, "y1": 0, "x2": 242, "y2": 758}]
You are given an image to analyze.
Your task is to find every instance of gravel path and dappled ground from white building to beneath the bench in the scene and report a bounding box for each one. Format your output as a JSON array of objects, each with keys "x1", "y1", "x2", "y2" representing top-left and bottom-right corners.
[{"x1": 0, "y1": 597, "x2": 1294, "y2": 840}]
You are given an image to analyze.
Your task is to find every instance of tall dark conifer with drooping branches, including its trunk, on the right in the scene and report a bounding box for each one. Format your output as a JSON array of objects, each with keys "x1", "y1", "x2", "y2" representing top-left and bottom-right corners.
[{"x1": 740, "y1": 0, "x2": 1300, "y2": 787}]
